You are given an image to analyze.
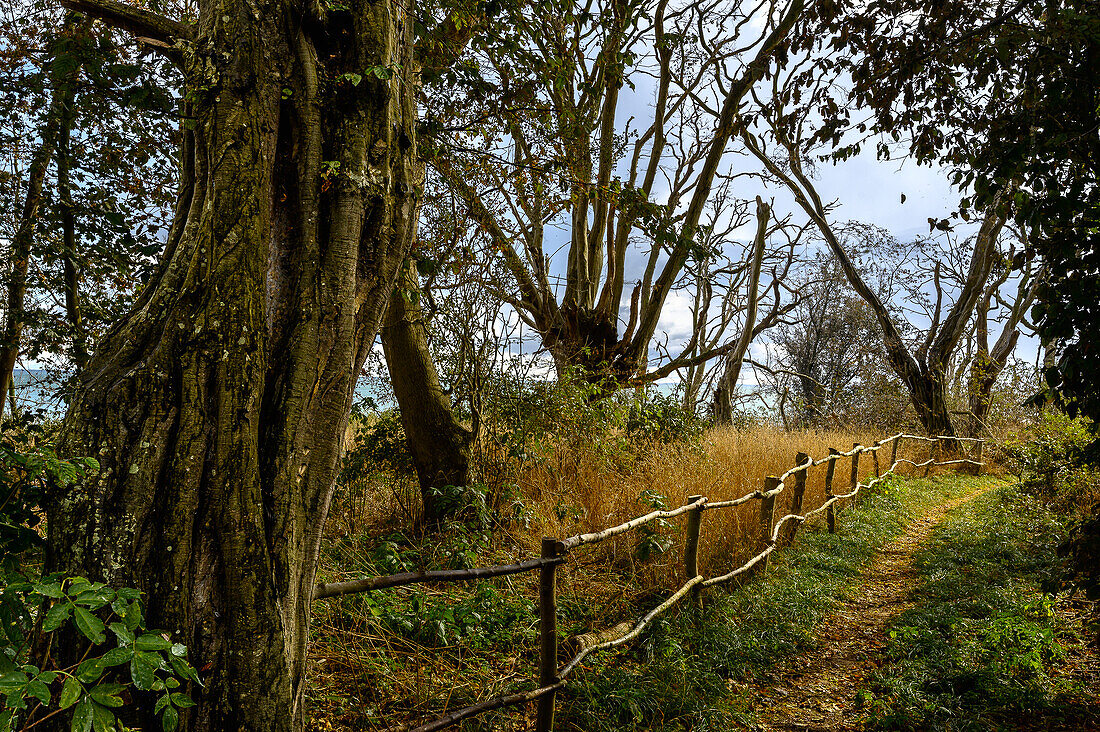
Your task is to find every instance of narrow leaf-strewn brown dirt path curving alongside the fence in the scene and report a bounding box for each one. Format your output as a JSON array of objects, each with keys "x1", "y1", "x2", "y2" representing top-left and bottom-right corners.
[{"x1": 754, "y1": 484, "x2": 997, "y2": 732}]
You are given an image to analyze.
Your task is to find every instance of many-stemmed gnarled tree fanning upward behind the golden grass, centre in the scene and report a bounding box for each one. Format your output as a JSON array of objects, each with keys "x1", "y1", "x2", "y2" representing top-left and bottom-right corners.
[{"x1": 430, "y1": 0, "x2": 804, "y2": 385}]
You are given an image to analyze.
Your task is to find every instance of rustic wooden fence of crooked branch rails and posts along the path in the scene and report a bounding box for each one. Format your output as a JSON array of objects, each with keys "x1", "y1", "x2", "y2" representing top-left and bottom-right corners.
[{"x1": 314, "y1": 434, "x2": 985, "y2": 732}]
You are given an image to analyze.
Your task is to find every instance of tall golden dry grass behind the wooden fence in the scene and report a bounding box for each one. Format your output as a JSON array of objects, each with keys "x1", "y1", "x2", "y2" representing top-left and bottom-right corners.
[{"x1": 499, "y1": 426, "x2": 946, "y2": 594}]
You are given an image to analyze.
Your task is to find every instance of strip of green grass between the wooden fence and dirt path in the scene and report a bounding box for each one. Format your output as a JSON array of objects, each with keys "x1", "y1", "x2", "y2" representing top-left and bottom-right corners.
[{"x1": 550, "y1": 477, "x2": 990, "y2": 732}]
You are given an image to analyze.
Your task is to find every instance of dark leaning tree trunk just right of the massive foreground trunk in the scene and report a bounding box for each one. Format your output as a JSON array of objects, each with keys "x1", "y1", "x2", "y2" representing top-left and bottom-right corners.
[{"x1": 382, "y1": 256, "x2": 474, "y2": 524}]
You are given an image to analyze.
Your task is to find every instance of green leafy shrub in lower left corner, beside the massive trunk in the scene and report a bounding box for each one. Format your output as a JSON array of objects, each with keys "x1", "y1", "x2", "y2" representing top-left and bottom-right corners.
[{"x1": 0, "y1": 431, "x2": 200, "y2": 732}]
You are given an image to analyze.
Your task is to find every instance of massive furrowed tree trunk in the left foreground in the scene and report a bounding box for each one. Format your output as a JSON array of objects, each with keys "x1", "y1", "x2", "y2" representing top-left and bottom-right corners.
[{"x1": 48, "y1": 0, "x2": 421, "y2": 732}]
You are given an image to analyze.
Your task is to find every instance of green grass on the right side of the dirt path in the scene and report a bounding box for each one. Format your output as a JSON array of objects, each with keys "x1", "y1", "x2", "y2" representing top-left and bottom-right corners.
[{"x1": 861, "y1": 485, "x2": 1100, "y2": 731}]
